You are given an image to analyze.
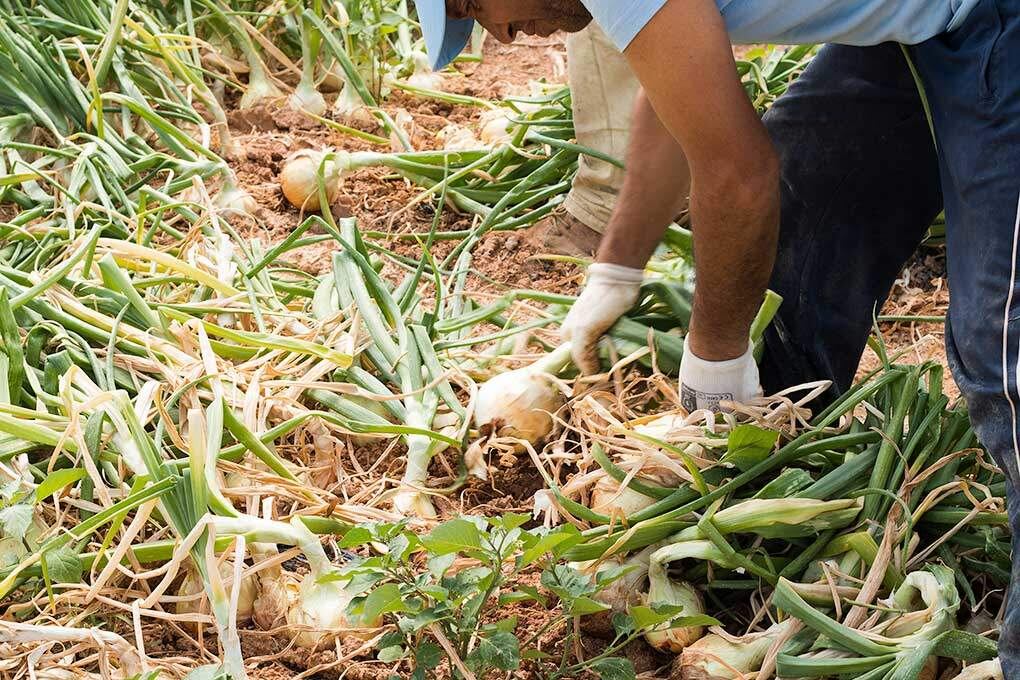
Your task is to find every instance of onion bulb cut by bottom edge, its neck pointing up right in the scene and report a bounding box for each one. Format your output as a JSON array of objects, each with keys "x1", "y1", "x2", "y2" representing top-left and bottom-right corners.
[{"x1": 670, "y1": 620, "x2": 792, "y2": 680}]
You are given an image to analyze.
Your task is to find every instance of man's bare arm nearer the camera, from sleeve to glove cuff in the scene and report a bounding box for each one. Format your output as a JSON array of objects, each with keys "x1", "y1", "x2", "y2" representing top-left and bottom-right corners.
[{"x1": 620, "y1": 0, "x2": 779, "y2": 361}]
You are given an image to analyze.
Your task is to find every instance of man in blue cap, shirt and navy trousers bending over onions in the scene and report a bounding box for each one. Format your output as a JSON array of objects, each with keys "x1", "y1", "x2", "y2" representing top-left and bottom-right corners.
[{"x1": 417, "y1": 0, "x2": 1020, "y2": 678}]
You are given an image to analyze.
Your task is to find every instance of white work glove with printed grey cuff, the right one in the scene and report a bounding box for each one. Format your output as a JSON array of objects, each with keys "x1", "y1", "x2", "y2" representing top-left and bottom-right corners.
[{"x1": 680, "y1": 336, "x2": 762, "y2": 413}]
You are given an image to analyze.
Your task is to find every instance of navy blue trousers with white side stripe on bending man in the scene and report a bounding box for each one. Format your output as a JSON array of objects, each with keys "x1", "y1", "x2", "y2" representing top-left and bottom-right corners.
[{"x1": 762, "y1": 0, "x2": 1020, "y2": 678}]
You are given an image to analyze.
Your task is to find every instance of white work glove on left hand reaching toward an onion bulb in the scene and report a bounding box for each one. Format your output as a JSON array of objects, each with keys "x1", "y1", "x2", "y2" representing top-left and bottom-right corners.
[{"x1": 560, "y1": 263, "x2": 645, "y2": 375}]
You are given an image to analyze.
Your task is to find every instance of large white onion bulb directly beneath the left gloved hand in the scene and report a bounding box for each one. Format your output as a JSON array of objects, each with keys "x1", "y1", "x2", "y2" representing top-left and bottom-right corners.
[{"x1": 474, "y1": 344, "x2": 570, "y2": 446}]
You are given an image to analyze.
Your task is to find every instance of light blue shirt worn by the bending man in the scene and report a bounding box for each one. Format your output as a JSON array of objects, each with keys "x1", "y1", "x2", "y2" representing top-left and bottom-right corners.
[{"x1": 581, "y1": 0, "x2": 980, "y2": 50}]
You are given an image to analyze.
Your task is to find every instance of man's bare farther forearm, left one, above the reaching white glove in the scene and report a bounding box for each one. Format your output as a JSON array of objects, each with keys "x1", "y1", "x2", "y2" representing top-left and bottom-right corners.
[{"x1": 598, "y1": 92, "x2": 691, "y2": 268}]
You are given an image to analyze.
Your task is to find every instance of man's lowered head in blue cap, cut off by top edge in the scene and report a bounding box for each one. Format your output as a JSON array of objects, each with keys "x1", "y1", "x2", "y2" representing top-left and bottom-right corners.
[{"x1": 415, "y1": 0, "x2": 592, "y2": 68}]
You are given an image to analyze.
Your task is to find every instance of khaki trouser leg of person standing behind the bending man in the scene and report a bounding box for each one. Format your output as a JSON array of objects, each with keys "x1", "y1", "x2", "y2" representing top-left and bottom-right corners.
[{"x1": 564, "y1": 22, "x2": 639, "y2": 233}]
